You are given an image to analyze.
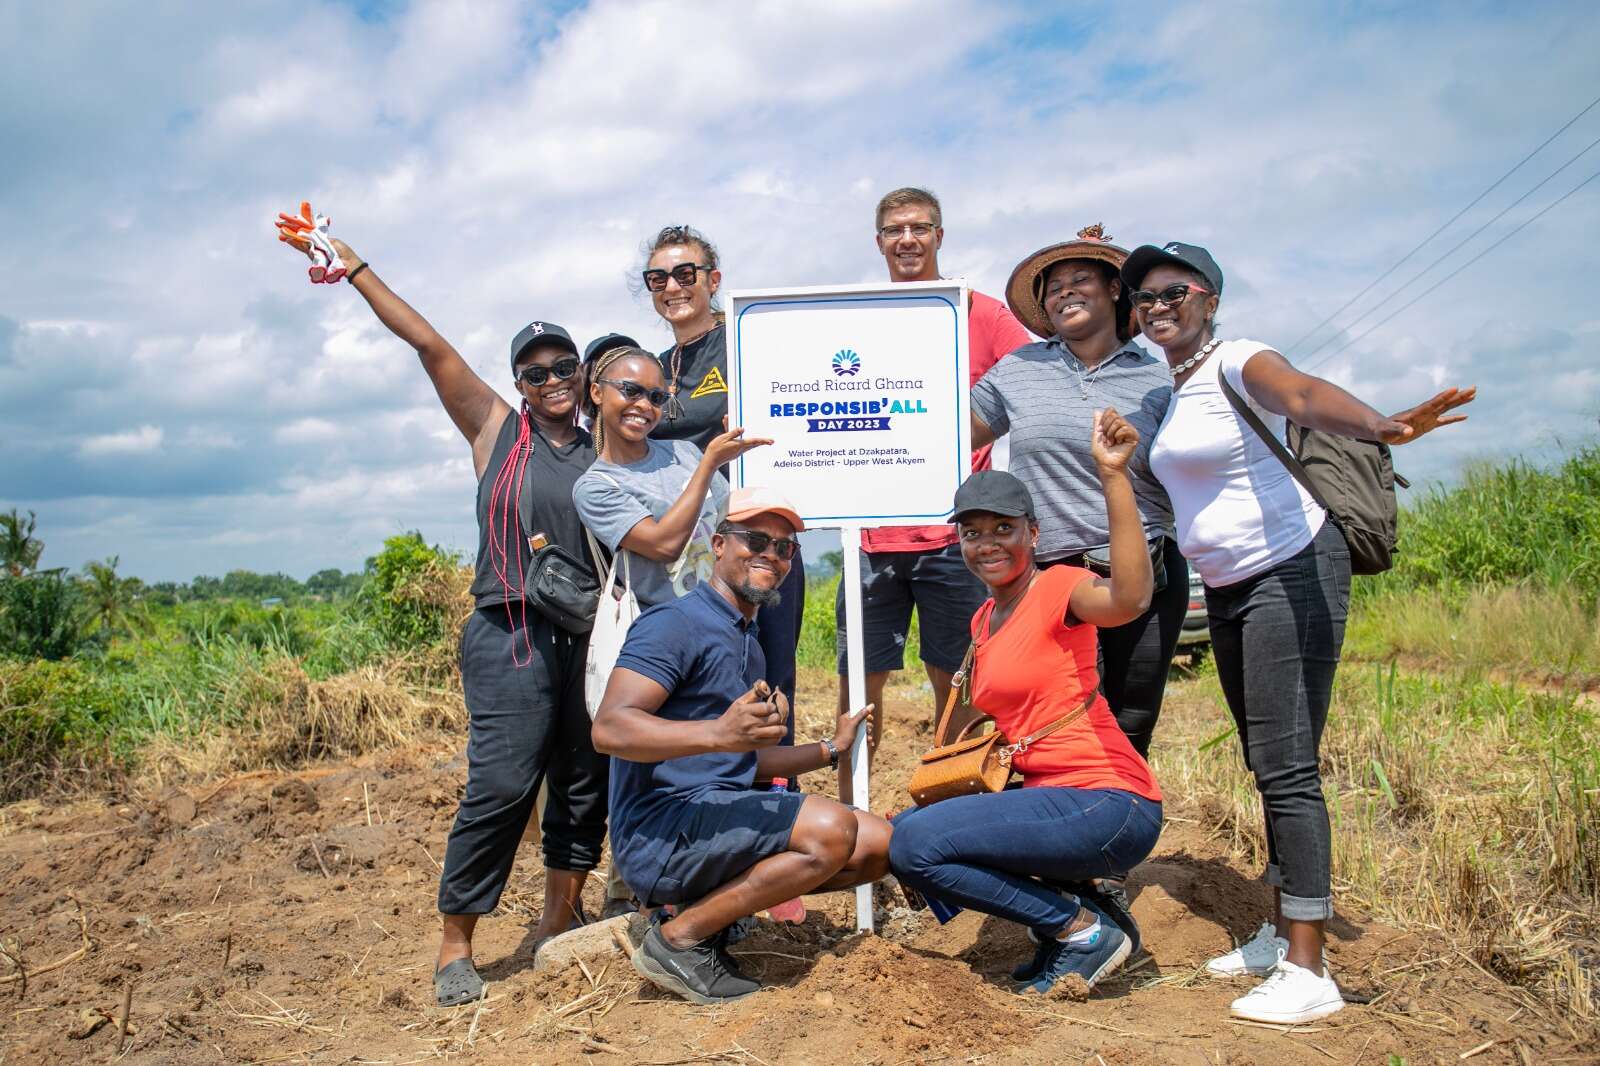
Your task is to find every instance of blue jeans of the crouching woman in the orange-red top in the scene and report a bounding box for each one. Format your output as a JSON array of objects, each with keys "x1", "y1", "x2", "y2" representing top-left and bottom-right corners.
[{"x1": 890, "y1": 786, "x2": 1162, "y2": 936}]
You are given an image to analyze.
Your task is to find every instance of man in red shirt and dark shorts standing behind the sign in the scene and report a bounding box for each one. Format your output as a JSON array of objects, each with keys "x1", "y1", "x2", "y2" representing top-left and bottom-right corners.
[{"x1": 835, "y1": 189, "x2": 1034, "y2": 771}]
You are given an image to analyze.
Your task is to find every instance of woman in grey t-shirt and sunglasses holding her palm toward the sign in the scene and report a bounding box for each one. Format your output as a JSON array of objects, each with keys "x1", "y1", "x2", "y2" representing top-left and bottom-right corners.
[{"x1": 573, "y1": 340, "x2": 771, "y2": 607}]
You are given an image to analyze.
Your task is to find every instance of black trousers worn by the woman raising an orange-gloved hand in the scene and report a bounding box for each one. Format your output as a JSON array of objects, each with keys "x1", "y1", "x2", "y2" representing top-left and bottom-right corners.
[{"x1": 438, "y1": 605, "x2": 610, "y2": 914}]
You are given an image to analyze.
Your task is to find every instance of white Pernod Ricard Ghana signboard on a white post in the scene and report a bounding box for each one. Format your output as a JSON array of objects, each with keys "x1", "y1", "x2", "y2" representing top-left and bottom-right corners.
[{"x1": 728, "y1": 280, "x2": 971, "y2": 932}]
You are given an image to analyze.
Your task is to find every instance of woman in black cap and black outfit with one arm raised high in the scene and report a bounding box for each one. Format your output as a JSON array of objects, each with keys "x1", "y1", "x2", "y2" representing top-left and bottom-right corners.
[{"x1": 281, "y1": 228, "x2": 608, "y2": 1007}]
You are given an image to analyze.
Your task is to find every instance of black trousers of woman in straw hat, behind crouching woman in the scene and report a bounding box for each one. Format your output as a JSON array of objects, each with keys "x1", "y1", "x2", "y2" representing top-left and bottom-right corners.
[{"x1": 1045, "y1": 538, "x2": 1189, "y2": 757}]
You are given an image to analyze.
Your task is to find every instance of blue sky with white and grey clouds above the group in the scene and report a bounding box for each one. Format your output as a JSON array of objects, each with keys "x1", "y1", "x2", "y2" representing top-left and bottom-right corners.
[{"x1": 0, "y1": 0, "x2": 1600, "y2": 579}]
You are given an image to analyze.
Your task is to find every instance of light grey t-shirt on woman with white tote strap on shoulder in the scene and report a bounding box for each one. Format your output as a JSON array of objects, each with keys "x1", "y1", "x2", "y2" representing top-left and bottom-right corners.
[{"x1": 573, "y1": 440, "x2": 728, "y2": 607}]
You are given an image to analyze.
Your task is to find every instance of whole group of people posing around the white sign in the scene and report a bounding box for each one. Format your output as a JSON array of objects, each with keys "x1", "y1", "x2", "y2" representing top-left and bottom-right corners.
[{"x1": 291, "y1": 189, "x2": 1474, "y2": 1023}]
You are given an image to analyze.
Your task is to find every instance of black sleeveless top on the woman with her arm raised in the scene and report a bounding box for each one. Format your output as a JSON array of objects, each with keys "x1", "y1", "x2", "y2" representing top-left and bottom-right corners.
[{"x1": 472, "y1": 411, "x2": 595, "y2": 607}]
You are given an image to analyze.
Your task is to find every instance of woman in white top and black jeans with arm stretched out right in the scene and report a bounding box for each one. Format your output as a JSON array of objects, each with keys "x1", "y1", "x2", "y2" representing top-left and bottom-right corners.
[{"x1": 1122, "y1": 242, "x2": 1475, "y2": 1024}]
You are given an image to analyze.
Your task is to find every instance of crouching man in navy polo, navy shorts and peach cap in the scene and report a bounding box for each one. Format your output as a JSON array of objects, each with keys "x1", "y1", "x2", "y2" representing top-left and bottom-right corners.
[{"x1": 594, "y1": 488, "x2": 890, "y2": 1004}]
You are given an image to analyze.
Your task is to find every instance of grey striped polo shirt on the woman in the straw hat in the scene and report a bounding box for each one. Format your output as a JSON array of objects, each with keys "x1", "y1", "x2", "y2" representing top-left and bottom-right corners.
[{"x1": 973, "y1": 338, "x2": 1173, "y2": 562}]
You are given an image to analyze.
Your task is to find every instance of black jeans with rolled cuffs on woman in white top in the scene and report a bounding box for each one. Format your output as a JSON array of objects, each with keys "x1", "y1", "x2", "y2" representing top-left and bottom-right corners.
[{"x1": 1205, "y1": 519, "x2": 1350, "y2": 915}]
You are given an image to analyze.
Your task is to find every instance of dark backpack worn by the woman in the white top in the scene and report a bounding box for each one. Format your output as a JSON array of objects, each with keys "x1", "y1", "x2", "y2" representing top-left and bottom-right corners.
[{"x1": 1216, "y1": 373, "x2": 1411, "y2": 575}]
